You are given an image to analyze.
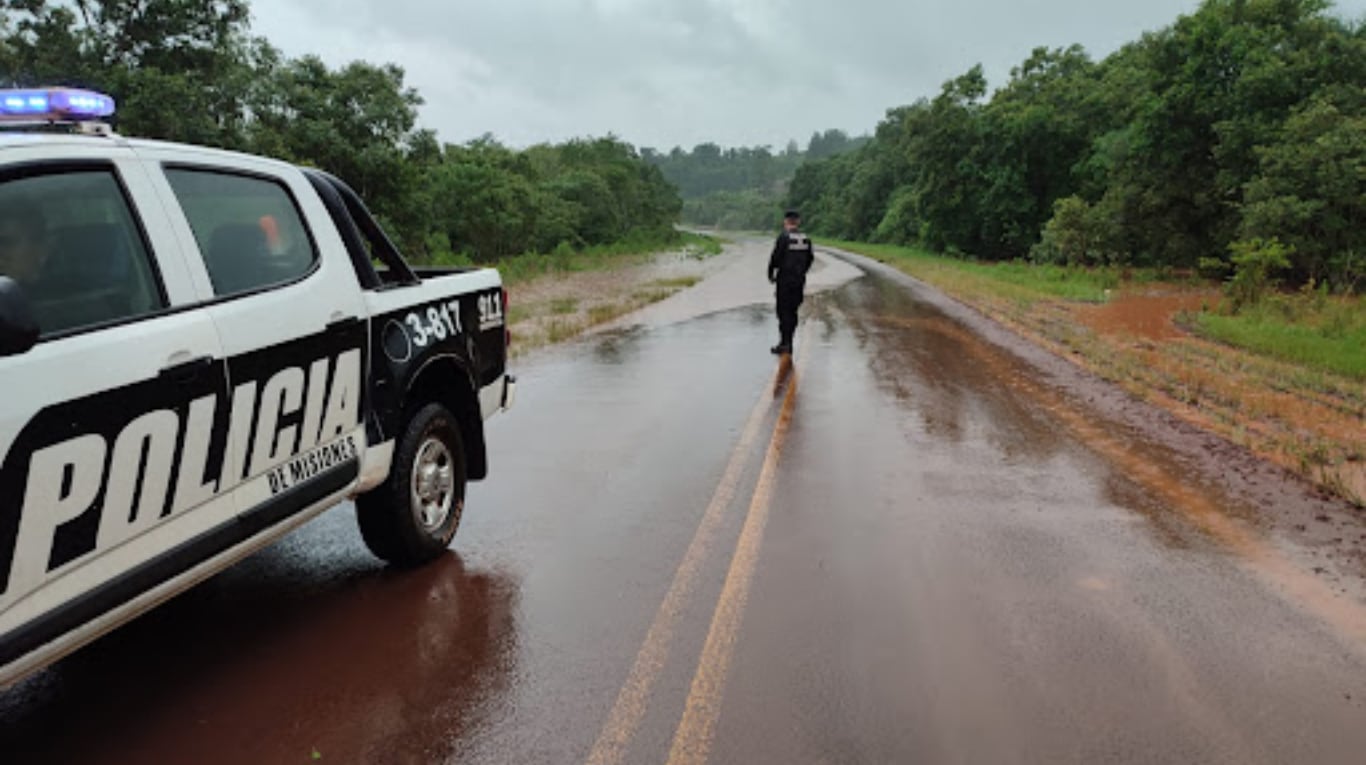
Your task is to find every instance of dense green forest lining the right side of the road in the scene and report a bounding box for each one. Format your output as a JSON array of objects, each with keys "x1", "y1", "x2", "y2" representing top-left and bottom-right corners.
[{"x1": 788, "y1": 0, "x2": 1366, "y2": 291}]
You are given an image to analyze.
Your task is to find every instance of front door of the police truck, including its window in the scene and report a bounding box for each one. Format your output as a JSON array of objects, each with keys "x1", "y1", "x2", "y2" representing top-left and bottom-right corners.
[{"x1": 0, "y1": 146, "x2": 232, "y2": 665}]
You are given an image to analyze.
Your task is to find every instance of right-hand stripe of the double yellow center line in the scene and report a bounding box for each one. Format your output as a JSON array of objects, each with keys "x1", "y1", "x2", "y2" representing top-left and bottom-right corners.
[{"x1": 668, "y1": 322, "x2": 810, "y2": 765}]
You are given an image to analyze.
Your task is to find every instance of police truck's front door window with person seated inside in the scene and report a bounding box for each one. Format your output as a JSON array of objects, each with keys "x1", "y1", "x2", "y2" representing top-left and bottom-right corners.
[{"x1": 0, "y1": 169, "x2": 167, "y2": 337}]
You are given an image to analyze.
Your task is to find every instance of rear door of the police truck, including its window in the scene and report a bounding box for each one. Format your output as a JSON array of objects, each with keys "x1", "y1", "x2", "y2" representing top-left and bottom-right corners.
[{"x1": 146, "y1": 157, "x2": 367, "y2": 529}]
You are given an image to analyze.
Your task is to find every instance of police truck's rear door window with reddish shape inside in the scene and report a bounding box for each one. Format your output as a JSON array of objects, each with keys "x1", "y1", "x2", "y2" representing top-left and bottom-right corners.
[{"x1": 167, "y1": 168, "x2": 317, "y2": 298}]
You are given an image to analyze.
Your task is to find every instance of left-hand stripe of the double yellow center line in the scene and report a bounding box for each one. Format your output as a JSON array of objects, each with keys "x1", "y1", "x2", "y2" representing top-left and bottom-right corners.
[{"x1": 586, "y1": 360, "x2": 780, "y2": 765}]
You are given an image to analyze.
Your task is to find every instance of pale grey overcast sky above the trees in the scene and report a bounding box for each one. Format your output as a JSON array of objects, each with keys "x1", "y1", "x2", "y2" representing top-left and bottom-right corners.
[{"x1": 253, "y1": 0, "x2": 1366, "y2": 149}]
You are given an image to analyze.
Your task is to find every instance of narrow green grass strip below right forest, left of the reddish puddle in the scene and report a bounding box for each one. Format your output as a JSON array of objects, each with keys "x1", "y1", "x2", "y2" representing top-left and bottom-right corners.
[{"x1": 817, "y1": 239, "x2": 1141, "y2": 303}]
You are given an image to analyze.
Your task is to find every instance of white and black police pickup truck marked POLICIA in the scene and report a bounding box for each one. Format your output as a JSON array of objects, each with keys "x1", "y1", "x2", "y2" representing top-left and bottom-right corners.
[{"x1": 0, "y1": 89, "x2": 514, "y2": 687}]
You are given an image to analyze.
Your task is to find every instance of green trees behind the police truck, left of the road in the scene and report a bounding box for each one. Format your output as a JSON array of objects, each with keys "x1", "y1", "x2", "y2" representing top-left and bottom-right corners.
[{"x1": 0, "y1": 0, "x2": 682, "y2": 262}]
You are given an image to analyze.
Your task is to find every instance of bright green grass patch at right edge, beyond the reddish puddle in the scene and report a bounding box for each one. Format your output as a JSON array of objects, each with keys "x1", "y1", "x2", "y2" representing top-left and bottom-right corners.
[{"x1": 1191, "y1": 296, "x2": 1366, "y2": 380}]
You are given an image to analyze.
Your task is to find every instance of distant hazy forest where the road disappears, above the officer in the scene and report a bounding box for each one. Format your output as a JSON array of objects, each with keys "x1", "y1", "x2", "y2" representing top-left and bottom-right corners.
[{"x1": 641, "y1": 130, "x2": 867, "y2": 230}]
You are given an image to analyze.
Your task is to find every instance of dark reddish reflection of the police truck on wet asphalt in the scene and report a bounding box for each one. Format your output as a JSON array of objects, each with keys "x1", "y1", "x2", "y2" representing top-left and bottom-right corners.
[{"x1": 0, "y1": 543, "x2": 516, "y2": 764}]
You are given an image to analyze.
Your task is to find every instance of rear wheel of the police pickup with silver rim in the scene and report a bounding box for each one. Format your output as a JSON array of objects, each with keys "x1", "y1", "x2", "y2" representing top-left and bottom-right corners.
[{"x1": 355, "y1": 404, "x2": 466, "y2": 566}]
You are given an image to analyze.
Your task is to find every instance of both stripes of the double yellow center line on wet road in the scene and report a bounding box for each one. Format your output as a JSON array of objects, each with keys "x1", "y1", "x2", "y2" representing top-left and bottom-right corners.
[{"x1": 586, "y1": 326, "x2": 809, "y2": 765}]
